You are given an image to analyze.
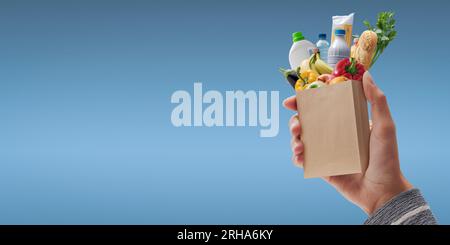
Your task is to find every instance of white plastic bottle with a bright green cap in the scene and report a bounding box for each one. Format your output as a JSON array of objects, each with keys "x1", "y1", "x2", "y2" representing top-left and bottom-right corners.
[{"x1": 289, "y1": 32, "x2": 316, "y2": 69}]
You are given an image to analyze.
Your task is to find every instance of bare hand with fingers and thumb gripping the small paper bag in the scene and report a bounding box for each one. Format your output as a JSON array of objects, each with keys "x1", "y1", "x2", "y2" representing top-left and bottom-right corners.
[{"x1": 283, "y1": 72, "x2": 412, "y2": 215}]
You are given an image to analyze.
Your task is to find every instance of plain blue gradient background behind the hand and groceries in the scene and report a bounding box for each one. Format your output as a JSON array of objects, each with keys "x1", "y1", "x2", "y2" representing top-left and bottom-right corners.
[{"x1": 0, "y1": 0, "x2": 450, "y2": 224}]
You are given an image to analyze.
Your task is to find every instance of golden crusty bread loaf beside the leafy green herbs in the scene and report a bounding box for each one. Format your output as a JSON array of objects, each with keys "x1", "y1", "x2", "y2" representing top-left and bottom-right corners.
[{"x1": 355, "y1": 30, "x2": 378, "y2": 70}]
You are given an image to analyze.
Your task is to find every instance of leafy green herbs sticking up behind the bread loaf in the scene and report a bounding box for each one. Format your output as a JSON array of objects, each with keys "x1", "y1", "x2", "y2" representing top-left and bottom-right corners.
[{"x1": 364, "y1": 12, "x2": 397, "y2": 66}]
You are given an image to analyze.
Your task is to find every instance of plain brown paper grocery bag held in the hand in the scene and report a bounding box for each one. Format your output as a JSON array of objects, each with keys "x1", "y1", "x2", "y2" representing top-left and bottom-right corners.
[{"x1": 297, "y1": 81, "x2": 370, "y2": 178}]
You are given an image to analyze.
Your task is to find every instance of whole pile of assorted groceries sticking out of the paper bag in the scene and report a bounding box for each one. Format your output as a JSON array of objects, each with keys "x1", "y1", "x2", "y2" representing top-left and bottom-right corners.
[{"x1": 280, "y1": 12, "x2": 397, "y2": 91}]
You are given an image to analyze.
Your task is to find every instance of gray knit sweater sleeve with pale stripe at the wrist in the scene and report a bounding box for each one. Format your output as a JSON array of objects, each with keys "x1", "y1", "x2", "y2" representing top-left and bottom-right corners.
[{"x1": 364, "y1": 189, "x2": 437, "y2": 225}]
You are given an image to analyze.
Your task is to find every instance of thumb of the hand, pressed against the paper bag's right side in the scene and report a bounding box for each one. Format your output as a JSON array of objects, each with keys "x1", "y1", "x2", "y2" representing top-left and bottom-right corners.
[{"x1": 363, "y1": 71, "x2": 392, "y2": 125}]
